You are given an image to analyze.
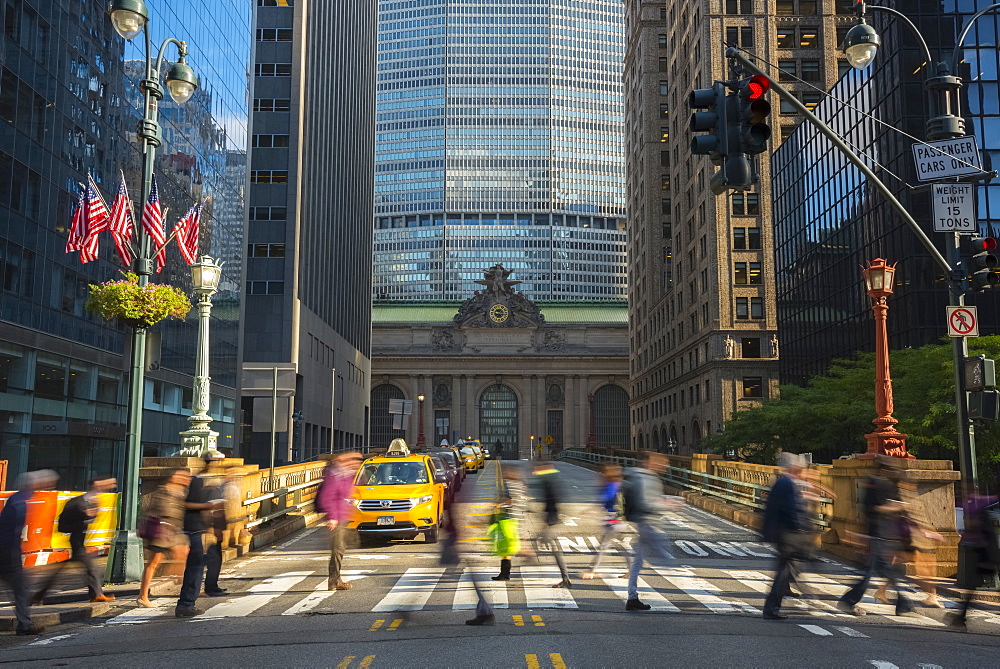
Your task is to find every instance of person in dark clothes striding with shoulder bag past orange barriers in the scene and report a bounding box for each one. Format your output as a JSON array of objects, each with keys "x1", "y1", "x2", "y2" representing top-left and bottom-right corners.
[{"x1": 34, "y1": 474, "x2": 118, "y2": 602}]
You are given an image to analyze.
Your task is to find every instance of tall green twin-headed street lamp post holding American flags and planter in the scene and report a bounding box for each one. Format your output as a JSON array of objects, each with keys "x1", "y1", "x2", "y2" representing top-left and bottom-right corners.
[{"x1": 106, "y1": 0, "x2": 198, "y2": 583}]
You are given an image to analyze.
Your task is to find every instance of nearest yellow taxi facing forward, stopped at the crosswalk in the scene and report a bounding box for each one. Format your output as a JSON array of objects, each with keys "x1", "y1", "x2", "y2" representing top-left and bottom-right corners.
[{"x1": 347, "y1": 439, "x2": 446, "y2": 544}]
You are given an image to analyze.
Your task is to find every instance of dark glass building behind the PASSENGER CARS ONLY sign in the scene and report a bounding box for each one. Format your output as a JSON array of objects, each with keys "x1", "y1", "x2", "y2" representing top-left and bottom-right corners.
[{"x1": 771, "y1": 0, "x2": 1000, "y2": 383}]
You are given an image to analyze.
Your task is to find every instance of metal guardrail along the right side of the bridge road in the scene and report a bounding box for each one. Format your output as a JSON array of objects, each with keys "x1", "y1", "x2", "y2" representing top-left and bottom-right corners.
[{"x1": 557, "y1": 450, "x2": 833, "y2": 527}]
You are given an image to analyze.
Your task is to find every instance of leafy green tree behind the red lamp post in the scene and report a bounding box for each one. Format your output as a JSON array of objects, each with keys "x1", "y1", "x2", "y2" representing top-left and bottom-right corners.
[{"x1": 708, "y1": 336, "x2": 1000, "y2": 478}]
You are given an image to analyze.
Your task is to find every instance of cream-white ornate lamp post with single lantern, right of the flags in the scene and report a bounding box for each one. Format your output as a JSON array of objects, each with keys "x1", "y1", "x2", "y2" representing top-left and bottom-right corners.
[{"x1": 181, "y1": 256, "x2": 222, "y2": 455}]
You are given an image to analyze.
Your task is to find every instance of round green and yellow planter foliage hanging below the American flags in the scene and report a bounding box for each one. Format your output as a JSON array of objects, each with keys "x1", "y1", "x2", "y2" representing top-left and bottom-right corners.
[{"x1": 86, "y1": 272, "x2": 191, "y2": 328}]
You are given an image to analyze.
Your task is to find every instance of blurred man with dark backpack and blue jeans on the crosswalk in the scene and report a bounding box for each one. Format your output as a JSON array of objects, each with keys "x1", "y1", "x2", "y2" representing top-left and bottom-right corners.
[{"x1": 622, "y1": 451, "x2": 683, "y2": 611}]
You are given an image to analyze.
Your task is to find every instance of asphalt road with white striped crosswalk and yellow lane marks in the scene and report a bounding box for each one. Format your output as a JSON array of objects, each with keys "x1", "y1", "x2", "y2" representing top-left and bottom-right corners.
[{"x1": 0, "y1": 462, "x2": 1000, "y2": 669}]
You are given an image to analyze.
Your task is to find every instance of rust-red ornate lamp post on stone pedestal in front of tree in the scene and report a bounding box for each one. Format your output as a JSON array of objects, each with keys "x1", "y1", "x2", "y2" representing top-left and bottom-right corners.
[{"x1": 861, "y1": 258, "x2": 913, "y2": 458}]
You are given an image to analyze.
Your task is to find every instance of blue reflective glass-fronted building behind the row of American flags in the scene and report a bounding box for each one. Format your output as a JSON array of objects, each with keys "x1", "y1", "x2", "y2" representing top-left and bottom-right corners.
[{"x1": 0, "y1": 0, "x2": 250, "y2": 488}]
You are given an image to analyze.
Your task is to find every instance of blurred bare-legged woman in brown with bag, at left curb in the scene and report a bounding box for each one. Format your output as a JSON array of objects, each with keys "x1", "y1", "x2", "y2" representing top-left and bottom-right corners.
[{"x1": 135, "y1": 469, "x2": 191, "y2": 609}]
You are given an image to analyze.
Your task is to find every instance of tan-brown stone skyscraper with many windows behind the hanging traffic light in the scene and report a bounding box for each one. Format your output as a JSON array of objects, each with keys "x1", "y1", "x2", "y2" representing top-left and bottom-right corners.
[{"x1": 625, "y1": 0, "x2": 855, "y2": 453}]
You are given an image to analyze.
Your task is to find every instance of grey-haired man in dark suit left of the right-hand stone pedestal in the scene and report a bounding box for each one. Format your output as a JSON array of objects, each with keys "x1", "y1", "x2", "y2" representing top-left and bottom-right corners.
[{"x1": 761, "y1": 453, "x2": 812, "y2": 620}]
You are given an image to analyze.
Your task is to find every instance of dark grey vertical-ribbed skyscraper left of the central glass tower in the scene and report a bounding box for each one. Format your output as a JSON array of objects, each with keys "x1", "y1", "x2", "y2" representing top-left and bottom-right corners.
[{"x1": 243, "y1": 0, "x2": 376, "y2": 463}]
